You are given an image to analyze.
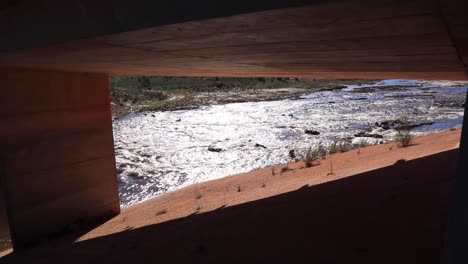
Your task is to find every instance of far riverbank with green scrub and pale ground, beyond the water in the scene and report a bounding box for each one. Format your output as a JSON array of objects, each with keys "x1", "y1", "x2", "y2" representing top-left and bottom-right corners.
[{"x1": 110, "y1": 76, "x2": 377, "y2": 119}]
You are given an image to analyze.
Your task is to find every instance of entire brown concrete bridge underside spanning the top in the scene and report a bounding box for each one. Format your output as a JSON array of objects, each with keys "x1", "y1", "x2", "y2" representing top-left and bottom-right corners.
[{"x1": 0, "y1": 0, "x2": 468, "y2": 80}]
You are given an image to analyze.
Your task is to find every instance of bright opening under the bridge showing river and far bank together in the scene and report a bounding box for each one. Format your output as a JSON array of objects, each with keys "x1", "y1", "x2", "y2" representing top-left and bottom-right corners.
[{"x1": 110, "y1": 76, "x2": 468, "y2": 208}]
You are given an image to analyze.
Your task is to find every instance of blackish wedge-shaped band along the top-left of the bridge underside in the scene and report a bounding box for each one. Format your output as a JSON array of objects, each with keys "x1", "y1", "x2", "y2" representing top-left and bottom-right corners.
[{"x1": 0, "y1": 0, "x2": 336, "y2": 51}]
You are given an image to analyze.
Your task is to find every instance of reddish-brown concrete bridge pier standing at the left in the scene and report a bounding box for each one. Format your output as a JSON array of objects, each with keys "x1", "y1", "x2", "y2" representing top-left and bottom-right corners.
[{"x1": 0, "y1": 68, "x2": 120, "y2": 249}]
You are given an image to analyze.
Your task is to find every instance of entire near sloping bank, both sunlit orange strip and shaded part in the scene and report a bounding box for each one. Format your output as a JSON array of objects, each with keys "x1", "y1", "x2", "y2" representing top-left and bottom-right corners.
[{"x1": 2, "y1": 129, "x2": 460, "y2": 263}]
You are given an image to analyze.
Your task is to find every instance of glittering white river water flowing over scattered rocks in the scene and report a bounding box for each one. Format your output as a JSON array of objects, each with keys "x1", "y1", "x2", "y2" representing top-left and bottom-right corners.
[{"x1": 113, "y1": 80, "x2": 467, "y2": 208}]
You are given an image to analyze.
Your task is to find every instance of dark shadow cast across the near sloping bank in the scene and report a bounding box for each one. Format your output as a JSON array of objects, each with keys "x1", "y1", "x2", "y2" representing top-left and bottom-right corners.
[{"x1": 0, "y1": 150, "x2": 458, "y2": 264}]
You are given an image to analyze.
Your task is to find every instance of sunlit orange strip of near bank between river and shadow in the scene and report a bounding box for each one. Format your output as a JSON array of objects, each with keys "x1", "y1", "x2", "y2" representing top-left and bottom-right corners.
[{"x1": 88, "y1": 129, "x2": 461, "y2": 239}]
